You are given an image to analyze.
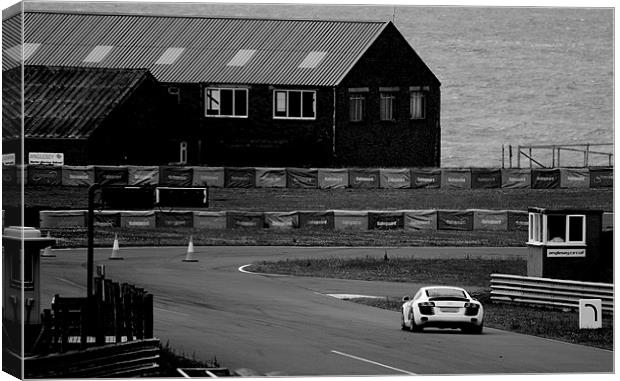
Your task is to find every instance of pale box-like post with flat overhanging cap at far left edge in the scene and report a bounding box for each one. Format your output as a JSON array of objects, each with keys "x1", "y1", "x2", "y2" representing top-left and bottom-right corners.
[{"x1": 2, "y1": 226, "x2": 56, "y2": 352}]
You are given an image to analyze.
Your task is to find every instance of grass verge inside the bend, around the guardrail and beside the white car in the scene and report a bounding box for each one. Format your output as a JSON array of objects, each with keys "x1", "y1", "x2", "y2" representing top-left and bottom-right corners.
[{"x1": 249, "y1": 257, "x2": 613, "y2": 350}]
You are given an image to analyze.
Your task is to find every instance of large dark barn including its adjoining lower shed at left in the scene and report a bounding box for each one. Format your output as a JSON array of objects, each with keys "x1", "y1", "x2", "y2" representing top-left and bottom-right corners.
[{"x1": 3, "y1": 12, "x2": 440, "y2": 167}]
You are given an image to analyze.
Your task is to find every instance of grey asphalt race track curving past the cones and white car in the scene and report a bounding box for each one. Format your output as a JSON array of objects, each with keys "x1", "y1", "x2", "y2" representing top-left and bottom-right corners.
[{"x1": 41, "y1": 246, "x2": 613, "y2": 376}]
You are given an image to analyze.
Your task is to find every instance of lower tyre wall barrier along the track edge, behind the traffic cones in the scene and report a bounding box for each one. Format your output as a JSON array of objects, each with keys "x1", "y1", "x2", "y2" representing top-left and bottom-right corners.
[{"x1": 39, "y1": 209, "x2": 536, "y2": 231}]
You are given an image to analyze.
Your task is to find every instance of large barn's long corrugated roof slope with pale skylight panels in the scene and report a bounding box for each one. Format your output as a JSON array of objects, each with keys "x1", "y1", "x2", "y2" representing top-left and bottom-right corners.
[{"x1": 3, "y1": 12, "x2": 388, "y2": 86}]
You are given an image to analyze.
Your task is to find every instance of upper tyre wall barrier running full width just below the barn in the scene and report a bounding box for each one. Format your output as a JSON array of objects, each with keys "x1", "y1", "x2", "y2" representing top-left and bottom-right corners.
[{"x1": 2, "y1": 165, "x2": 614, "y2": 189}]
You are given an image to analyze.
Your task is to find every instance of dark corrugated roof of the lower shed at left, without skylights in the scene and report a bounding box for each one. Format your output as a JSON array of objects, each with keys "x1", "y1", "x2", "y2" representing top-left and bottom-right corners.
[{"x1": 2, "y1": 66, "x2": 152, "y2": 139}]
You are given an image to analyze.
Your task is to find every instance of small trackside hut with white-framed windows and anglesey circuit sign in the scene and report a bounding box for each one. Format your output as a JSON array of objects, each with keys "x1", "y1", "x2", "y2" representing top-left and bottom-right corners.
[{"x1": 527, "y1": 208, "x2": 613, "y2": 282}]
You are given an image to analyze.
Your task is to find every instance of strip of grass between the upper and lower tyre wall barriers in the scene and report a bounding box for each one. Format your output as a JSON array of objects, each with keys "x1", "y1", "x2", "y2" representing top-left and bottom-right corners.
[{"x1": 12, "y1": 186, "x2": 613, "y2": 211}]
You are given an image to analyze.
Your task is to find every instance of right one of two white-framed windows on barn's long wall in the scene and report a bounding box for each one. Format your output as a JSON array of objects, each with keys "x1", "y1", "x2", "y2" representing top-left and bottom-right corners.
[{"x1": 273, "y1": 90, "x2": 316, "y2": 119}]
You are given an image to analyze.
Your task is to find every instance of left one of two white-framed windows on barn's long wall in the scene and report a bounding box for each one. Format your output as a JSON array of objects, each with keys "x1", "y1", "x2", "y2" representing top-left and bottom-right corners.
[{"x1": 205, "y1": 87, "x2": 248, "y2": 118}]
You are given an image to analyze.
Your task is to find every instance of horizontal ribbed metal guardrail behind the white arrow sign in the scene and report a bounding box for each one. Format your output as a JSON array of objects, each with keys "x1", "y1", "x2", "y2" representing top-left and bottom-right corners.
[{"x1": 491, "y1": 274, "x2": 614, "y2": 314}]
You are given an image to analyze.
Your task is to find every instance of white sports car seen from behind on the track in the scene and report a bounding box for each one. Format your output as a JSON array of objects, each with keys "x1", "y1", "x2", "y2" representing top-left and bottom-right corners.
[{"x1": 401, "y1": 286, "x2": 484, "y2": 334}]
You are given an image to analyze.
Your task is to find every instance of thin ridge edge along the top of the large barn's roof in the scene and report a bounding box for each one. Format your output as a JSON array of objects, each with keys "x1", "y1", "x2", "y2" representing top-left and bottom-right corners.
[{"x1": 23, "y1": 9, "x2": 390, "y2": 24}]
